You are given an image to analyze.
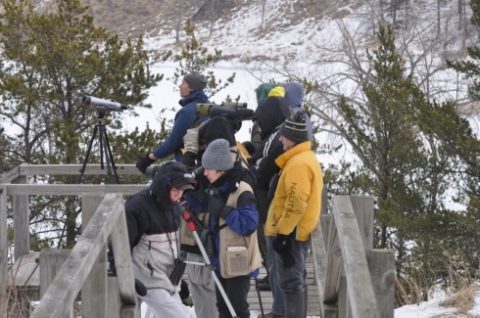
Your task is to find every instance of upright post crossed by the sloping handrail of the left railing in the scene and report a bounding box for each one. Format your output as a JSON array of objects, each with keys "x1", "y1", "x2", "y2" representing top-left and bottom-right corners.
[{"x1": 81, "y1": 193, "x2": 107, "y2": 318}]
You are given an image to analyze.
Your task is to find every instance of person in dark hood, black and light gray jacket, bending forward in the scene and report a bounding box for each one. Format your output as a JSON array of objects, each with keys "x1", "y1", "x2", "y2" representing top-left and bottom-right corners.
[{"x1": 125, "y1": 161, "x2": 195, "y2": 318}]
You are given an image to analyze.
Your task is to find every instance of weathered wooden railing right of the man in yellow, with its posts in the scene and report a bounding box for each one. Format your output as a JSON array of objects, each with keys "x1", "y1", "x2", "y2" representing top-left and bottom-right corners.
[{"x1": 312, "y1": 196, "x2": 395, "y2": 318}]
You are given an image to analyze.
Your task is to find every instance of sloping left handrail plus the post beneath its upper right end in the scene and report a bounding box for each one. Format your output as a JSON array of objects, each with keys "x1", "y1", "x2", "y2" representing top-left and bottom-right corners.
[{"x1": 31, "y1": 194, "x2": 136, "y2": 318}]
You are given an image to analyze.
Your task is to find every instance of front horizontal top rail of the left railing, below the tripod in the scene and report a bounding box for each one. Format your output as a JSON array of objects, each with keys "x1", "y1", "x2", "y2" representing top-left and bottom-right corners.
[{"x1": 4, "y1": 184, "x2": 147, "y2": 195}]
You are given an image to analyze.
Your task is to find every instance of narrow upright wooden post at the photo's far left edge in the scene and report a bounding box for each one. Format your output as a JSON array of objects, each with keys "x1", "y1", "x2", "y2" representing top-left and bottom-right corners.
[{"x1": 0, "y1": 187, "x2": 8, "y2": 318}]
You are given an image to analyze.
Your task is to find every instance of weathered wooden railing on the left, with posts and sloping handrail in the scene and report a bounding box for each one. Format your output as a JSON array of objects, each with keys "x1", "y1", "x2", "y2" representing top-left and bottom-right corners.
[{"x1": 0, "y1": 165, "x2": 145, "y2": 317}]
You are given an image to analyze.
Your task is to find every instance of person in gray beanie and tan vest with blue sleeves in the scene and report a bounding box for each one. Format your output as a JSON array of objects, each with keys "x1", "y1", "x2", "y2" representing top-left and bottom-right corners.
[{"x1": 202, "y1": 139, "x2": 262, "y2": 318}]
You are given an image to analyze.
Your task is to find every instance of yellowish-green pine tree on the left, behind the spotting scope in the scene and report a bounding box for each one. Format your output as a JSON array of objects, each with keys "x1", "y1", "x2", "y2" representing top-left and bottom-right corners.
[{"x1": 0, "y1": 0, "x2": 160, "y2": 245}]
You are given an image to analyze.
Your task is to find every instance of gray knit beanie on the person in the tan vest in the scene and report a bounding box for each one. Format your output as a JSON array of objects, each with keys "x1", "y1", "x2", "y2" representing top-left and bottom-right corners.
[{"x1": 202, "y1": 139, "x2": 234, "y2": 171}]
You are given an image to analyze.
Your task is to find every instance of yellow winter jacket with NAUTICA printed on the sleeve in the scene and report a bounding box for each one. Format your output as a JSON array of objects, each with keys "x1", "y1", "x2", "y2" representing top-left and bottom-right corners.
[{"x1": 265, "y1": 141, "x2": 323, "y2": 241}]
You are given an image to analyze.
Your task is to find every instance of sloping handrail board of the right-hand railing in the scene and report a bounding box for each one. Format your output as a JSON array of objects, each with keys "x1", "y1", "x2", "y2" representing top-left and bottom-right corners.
[{"x1": 333, "y1": 196, "x2": 379, "y2": 318}]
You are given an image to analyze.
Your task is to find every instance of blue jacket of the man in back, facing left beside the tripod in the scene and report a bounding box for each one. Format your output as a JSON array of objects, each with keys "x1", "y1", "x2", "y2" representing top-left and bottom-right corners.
[{"x1": 153, "y1": 91, "x2": 208, "y2": 160}]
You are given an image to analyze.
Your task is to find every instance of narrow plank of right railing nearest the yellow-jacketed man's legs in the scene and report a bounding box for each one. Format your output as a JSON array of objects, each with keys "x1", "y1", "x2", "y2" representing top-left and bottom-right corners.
[{"x1": 312, "y1": 222, "x2": 327, "y2": 313}]
